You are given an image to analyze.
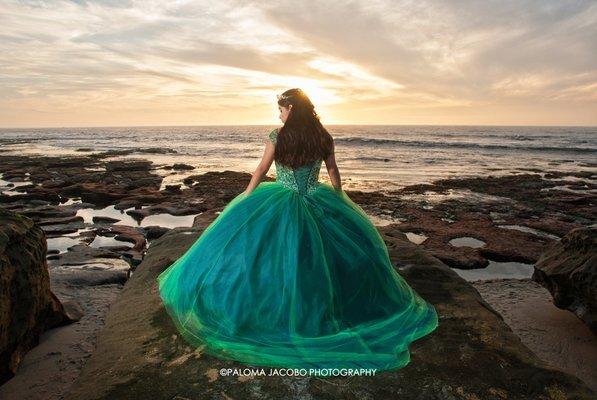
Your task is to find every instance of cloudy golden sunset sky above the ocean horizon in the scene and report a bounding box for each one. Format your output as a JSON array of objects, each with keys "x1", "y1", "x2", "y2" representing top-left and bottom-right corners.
[{"x1": 0, "y1": 0, "x2": 597, "y2": 127}]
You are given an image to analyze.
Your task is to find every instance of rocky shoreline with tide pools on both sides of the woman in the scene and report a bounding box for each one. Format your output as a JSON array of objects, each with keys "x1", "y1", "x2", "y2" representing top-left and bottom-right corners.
[{"x1": 0, "y1": 149, "x2": 597, "y2": 399}]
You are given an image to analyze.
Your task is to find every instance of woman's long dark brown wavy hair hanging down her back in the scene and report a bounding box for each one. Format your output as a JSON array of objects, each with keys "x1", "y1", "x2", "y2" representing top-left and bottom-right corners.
[{"x1": 274, "y1": 88, "x2": 334, "y2": 168}]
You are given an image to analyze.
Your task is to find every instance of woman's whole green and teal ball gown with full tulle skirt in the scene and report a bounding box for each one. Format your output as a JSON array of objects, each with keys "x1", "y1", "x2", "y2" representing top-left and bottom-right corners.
[{"x1": 157, "y1": 129, "x2": 438, "y2": 371}]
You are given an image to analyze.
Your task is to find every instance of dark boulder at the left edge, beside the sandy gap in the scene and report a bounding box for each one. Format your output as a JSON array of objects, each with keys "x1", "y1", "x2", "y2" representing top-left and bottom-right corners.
[{"x1": 0, "y1": 208, "x2": 81, "y2": 384}]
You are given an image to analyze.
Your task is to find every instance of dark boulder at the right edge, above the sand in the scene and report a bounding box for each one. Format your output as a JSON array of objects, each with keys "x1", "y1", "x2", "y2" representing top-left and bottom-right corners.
[{"x1": 532, "y1": 225, "x2": 597, "y2": 334}]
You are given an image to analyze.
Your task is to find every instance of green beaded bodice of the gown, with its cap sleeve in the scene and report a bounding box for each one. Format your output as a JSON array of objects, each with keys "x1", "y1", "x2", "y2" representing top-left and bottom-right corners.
[{"x1": 269, "y1": 128, "x2": 323, "y2": 195}]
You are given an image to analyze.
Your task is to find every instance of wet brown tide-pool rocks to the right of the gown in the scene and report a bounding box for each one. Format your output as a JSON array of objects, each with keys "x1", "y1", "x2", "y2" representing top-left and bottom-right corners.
[{"x1": 350, "y1": 172, "x2": 597, "y2": 269}]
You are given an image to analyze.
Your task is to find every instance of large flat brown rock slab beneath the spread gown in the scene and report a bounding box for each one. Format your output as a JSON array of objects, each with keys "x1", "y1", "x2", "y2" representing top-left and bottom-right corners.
[{"x1": 66, "y1": 223, "x2": 597, "y2": 400}]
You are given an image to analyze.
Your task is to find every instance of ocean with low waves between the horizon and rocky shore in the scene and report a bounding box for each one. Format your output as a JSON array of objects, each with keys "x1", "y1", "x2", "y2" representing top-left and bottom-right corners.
[{"x1": 0, "y1": 125, "x2": 597, "y2": 191}]
